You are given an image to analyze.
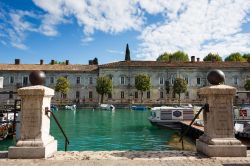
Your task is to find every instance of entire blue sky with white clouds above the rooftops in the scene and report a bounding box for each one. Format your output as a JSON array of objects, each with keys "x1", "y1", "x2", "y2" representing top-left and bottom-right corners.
[{"x1": 0, "y1": 0, "x2": 250, "y2": 64}]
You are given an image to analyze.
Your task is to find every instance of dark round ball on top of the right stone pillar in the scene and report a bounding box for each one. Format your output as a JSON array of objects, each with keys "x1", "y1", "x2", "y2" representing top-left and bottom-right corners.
[{"x1": 207, "y1": 69, "x2": 225, "y2": 85}]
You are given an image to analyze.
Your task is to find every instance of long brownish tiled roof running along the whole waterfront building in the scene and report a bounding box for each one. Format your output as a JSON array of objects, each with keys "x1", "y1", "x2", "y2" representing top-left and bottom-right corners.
[{"x1": 0, "y1": 61, "x2": 250, "y2": 72}]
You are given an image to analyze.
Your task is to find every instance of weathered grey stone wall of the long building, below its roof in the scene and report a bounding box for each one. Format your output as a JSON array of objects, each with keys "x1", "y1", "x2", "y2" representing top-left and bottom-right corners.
[{"x1": 0, "y1": 67, "x2": 250, "y2": 105}]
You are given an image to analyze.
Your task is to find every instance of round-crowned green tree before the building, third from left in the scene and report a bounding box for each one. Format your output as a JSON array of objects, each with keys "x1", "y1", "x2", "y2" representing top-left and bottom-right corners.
[{"x1": 135, "y1": 74, "x2": 151, "y2": 103}]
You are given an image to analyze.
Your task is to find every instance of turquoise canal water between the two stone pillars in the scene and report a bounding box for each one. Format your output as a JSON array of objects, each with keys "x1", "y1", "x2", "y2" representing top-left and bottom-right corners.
[{"x1": 0, "y1": 110, "x2": 180, "y2": 151}]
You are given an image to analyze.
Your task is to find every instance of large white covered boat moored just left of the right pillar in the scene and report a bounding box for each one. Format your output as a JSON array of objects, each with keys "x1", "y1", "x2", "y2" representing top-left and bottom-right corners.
[{"x1": 148, "y1": 105, "x2": 194, "y2": 129}]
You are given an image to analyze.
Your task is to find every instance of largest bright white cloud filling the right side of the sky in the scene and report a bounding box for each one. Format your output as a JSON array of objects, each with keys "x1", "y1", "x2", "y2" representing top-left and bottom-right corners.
[{"x1": 137, "y1": 0, "x2": 250, "y2": 60}]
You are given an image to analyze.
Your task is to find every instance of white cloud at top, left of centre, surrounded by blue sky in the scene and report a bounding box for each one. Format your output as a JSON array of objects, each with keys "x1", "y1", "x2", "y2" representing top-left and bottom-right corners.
[{"x1": 33, "y1": 0, "x2": 143, "y2": 38}]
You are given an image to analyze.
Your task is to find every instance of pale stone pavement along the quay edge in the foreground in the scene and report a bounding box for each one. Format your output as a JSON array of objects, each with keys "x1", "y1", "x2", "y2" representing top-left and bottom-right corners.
[{"x1": 0, "y1": 151, "x2": 250, "y2": 166}]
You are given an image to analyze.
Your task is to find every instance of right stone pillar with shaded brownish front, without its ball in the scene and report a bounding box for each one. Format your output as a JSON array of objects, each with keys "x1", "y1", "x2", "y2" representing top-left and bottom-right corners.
[{"x1": 196, "y1": 85, "x2": 247, "y2": 157}]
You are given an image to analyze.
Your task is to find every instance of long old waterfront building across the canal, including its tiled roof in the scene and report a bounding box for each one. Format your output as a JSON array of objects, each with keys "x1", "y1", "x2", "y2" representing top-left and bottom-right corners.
[{"x1": 0, "y1": 61, "x2": 250, "y2": 105}]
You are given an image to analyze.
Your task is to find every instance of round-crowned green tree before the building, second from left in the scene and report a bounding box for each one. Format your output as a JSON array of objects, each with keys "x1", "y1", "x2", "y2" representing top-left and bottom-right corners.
[{"x1": 96, "y1": 76, "x2": 112, "y2": 103}]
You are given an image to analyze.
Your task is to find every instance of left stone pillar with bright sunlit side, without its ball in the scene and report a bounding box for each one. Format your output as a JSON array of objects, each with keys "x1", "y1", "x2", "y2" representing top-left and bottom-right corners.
[{"x1": 8, "y1": 85, "x2": 57, "y2": 158}]
